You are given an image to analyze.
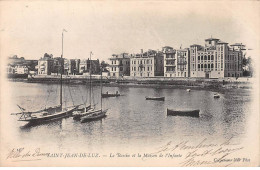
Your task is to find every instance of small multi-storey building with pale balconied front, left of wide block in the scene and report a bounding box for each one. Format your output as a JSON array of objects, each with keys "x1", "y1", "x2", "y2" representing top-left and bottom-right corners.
[{"x1": 108, "y1": 53, "x2": 130, "y2": 78}]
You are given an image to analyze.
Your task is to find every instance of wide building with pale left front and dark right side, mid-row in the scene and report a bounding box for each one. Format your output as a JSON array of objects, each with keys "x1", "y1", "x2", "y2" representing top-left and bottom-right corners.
[{"x1": 130, "y1": 50, "x2": 164, "y2": 77}]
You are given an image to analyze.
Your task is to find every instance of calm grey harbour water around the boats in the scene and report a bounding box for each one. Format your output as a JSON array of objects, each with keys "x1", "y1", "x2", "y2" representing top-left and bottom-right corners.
[{"x1": 7, "y1": 82, "x2": 251, "y2": 152}]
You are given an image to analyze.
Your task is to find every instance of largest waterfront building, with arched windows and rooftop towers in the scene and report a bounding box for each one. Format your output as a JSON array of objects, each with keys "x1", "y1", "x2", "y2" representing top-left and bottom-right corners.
[{"x1": 190, "y1": 38, "x2": 243, "y2": 78}]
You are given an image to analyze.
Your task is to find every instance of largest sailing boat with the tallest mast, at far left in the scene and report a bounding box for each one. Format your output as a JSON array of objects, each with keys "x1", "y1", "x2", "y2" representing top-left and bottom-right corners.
[{"x1": 14, "y1": 30, "x2": 79, "y2": 124}]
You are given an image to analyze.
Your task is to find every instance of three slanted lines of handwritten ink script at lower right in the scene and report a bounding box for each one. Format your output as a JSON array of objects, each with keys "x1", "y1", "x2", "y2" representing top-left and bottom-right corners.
[{"x1": 152, "y1": 137, "x2": 250, "y2": 166}]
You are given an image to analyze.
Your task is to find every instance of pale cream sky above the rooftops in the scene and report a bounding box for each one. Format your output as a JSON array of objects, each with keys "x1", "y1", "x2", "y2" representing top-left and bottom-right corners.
[{"x1": 0, "y1": 1, "x2": 260, "y2": 60}]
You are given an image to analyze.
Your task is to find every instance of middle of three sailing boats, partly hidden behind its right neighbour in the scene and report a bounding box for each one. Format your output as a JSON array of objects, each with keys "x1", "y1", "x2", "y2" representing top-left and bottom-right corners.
[{"x1": 73, "y1": 52, "x2": 93, "y2": 120}]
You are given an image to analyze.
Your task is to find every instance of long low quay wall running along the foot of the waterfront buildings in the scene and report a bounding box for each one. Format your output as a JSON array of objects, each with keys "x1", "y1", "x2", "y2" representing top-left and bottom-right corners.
[{"x1": 27, "y1": 75, "x2": 254, "y2": 89}]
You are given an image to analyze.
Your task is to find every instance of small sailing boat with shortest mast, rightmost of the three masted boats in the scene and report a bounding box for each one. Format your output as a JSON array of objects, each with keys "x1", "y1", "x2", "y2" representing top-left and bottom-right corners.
[{"x1": 80, "y1": 52, "x2": 108, "y2": 123}]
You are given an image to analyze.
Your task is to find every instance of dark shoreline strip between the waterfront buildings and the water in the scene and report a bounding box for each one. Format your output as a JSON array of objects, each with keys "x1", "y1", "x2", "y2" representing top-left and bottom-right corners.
[{"x1": 8, "y1": 76, "x2": 253, "y2": 92}]
